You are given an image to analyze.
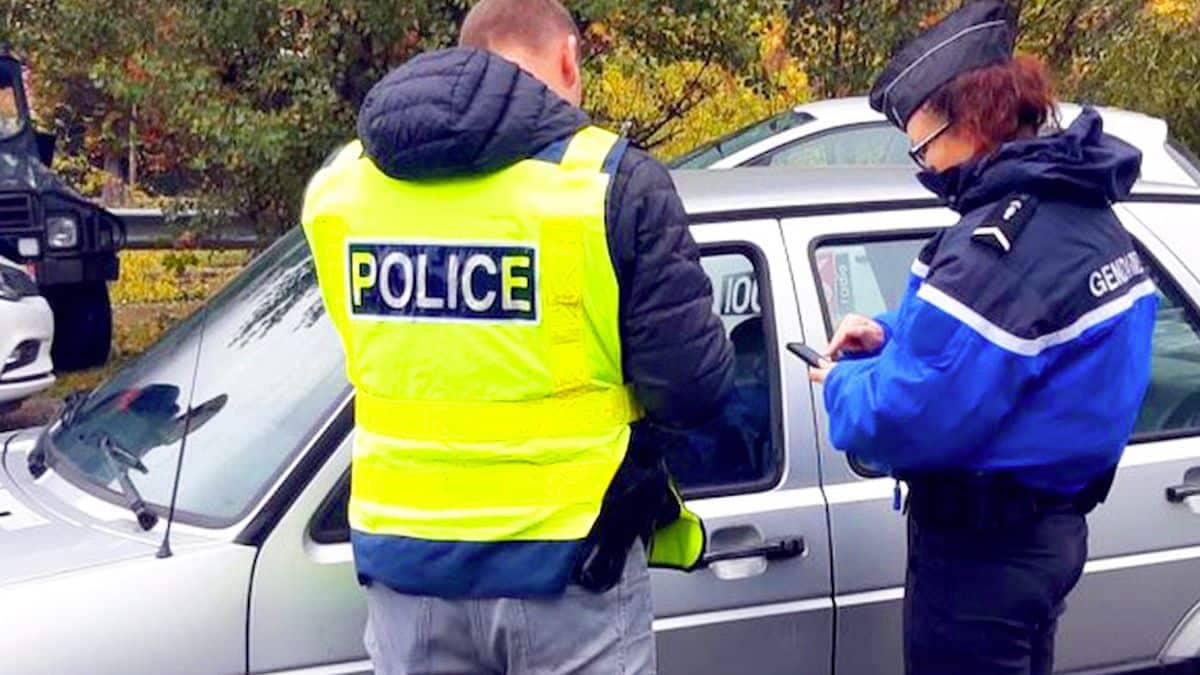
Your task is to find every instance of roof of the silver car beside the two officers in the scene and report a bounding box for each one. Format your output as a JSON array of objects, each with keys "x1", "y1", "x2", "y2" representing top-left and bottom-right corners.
[{"x1": 672, "y1": 167, "x2": 1200, "y2": 222}]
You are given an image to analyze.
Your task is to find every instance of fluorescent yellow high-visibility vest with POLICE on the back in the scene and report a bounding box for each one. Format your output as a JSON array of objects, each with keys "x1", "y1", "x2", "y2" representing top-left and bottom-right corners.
[{"x1": 304, "y1": 127, "x2": 703, "y2": 588}]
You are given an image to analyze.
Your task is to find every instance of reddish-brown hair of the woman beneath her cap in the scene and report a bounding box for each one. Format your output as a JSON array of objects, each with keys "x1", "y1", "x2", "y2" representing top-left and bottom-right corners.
[{"x1": 926, "y1": 54, "x2": 1057, "y2": 153}]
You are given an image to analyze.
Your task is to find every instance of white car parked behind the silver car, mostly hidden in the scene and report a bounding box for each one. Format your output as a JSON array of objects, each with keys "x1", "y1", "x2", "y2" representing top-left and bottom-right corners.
[{"x1": 670, "y1": 97, "x2": 1200, "y2": 186}]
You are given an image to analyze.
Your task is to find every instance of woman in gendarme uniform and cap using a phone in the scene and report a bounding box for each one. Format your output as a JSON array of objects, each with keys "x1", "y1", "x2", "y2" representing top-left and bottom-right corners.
[{"x1": 811, "y1": 2, "x2": 1157, "y2": 675}]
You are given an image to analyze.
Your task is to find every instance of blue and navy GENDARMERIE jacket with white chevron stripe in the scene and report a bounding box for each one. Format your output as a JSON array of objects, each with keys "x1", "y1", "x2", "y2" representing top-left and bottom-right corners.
[{"x1": 824, "y1": 110, "x2": 1158, "y2": 494}]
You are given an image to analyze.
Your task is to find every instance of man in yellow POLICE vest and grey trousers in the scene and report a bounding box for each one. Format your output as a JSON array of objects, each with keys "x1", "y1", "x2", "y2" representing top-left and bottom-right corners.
[{"x1": 304, "y1": 0, "x2": 732, "y2": 674}]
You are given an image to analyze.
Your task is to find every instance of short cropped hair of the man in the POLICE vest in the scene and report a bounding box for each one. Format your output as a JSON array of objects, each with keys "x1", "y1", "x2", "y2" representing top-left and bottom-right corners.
[{"x1": 458, "y1": 0, "x2": 581, "y2": 49}]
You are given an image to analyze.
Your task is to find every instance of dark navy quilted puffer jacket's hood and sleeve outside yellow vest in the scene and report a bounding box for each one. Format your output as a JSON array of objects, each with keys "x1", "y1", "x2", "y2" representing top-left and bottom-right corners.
[{"x1": 358, "y1": 49, "x2": 733, "y2": 428}]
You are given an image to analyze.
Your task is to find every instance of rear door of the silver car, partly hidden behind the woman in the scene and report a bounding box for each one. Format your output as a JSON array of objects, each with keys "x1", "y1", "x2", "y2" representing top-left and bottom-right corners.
[{"x1": 785, "y1": 201, "x2": 1200, "y2": 674}]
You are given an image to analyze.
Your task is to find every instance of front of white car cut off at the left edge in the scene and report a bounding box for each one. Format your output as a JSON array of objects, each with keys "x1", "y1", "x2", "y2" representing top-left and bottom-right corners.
[{"x1": 0, "y1": 252, "x2": 54, "y2": 413}]
